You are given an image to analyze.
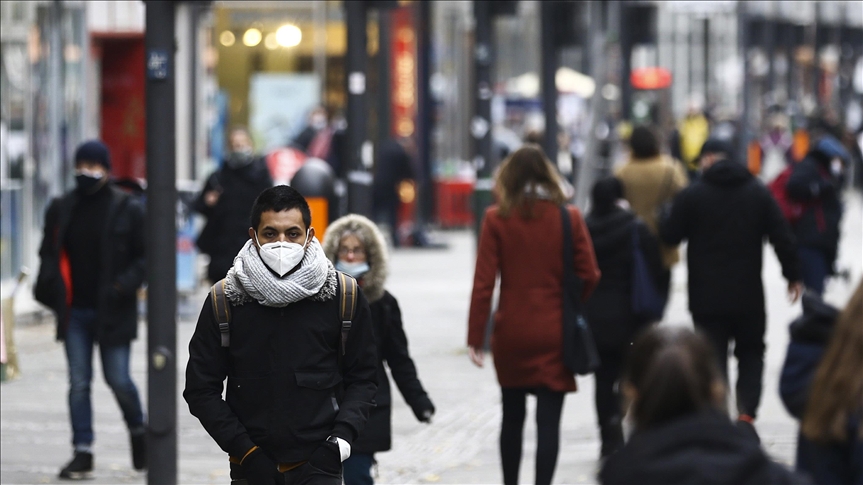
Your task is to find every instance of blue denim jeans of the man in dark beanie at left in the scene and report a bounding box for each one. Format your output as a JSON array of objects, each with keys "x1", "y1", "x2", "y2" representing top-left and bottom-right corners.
[{"x1": 65, "y1": 308, "x2": 144, "y2": 446}]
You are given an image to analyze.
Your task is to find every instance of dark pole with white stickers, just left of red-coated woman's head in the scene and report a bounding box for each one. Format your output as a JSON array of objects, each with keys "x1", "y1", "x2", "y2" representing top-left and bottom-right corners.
[{"x1": 470, "y1": 0, "x2": 494, "y2": 241}]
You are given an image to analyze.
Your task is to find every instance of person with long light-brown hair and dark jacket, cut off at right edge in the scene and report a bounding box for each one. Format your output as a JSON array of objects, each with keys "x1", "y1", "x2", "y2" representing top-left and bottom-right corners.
[{"x1": 779, "y1": 283, "x2": 863, "y2": 485}]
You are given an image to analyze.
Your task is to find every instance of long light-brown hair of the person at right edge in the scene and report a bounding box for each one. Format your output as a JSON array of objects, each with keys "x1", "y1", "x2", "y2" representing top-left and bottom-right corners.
[{"x1": 802, "y1": 281, "x2": 863, "y2": 443}]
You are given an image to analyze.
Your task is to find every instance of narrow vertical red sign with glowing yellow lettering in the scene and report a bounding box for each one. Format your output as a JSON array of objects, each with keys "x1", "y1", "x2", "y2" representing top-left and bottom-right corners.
[{"x1": 390, "y1": 6, "x2": 417, "y2": 137}]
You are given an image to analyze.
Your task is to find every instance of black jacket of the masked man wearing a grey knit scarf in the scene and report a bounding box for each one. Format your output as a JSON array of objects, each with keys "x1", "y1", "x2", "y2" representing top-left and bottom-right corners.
[{"x1": 183, "y1": 276, "x2": 377, "y2": 463}]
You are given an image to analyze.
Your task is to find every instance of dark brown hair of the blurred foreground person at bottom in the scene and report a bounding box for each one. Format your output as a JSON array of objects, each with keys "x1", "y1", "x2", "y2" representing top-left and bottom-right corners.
[{"x1": 623, "y1": 327, "x2": 723, "y2": 429}]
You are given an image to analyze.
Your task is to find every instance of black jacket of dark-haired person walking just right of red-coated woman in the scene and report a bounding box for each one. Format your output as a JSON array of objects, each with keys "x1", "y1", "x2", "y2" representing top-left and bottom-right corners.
[{"x1": 584, "y1": 208, "x2": 662, "y2": 350}]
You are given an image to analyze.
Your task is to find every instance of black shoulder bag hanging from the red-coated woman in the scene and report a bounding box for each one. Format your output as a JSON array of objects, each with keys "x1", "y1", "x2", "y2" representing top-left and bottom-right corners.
[{"x1": 560, "y1": 205, "x2": 599, "y2": 375}]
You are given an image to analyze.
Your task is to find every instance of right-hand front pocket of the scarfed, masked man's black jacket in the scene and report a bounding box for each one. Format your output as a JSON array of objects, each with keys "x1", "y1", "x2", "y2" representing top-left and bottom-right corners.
[{"x1": 291, "y1": 370, "x2": 342, "y2": 439}]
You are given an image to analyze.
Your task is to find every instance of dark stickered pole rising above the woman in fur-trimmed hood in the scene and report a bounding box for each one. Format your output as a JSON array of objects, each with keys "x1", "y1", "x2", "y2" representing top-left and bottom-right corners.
[{"x1": 344, "y1": 1, "x2": 372, "y2": 217}]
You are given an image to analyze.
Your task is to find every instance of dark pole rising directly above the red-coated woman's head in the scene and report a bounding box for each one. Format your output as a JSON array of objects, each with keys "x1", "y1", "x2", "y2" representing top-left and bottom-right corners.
[{"x1": 539, "y1": 2, "x2": 560, "y2": 161}]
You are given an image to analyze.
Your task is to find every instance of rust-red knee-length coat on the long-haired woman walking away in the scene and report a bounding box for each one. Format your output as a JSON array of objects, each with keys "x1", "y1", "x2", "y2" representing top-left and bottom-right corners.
[{"x1": 467, "y1": 200, "x2": 600, "y2": 392}]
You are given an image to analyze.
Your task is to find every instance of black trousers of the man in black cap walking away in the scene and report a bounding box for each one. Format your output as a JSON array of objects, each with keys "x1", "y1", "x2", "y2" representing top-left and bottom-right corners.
[{"x1": 694, "y1": 315, "x2": 766, "y2": 418}]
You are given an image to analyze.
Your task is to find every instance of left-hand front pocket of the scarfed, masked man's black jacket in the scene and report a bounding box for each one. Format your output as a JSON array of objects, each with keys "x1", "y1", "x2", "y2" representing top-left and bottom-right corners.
[{"x1": 226, "y1": 376, "x2": 272, "y2": 436}]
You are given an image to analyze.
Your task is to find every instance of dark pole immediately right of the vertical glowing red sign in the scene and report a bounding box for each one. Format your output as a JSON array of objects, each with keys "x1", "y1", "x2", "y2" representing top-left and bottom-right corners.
[{"x1": 414, "y1": 2, "x2": 435, "y2": 225}]
